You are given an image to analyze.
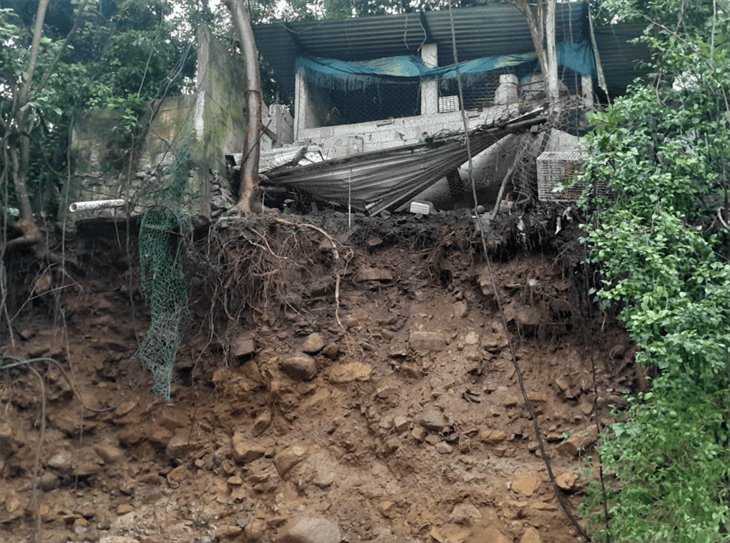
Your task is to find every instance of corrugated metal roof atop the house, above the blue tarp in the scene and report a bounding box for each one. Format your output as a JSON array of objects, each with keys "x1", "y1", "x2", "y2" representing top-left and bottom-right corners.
[{"x1": 254, "y1": 2, "x2": 648, "y2": 101}]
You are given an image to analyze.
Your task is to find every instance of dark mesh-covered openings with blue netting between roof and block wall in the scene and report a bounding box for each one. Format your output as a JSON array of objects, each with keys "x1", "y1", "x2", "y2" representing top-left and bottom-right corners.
[{"x1": 297, "y1": 41, "x2": 595, "y2": 128}]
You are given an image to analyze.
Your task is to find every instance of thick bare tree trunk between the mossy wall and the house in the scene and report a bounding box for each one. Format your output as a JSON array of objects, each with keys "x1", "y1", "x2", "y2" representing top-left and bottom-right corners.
[{"x1": 224, "y1": 0, "x2": 263, "y2": 214}]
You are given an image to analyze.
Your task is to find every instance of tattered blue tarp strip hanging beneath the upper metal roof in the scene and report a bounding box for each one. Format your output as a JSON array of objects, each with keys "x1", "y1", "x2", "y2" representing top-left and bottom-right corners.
[{"x1": 296, "y1": 42, "x2": 596, "y2": 90}]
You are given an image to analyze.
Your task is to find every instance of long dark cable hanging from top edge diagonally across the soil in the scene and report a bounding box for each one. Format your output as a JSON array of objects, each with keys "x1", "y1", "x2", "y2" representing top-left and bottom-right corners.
[{"x1": 449, "y1": 0, "x2": 591, "y2": 542}]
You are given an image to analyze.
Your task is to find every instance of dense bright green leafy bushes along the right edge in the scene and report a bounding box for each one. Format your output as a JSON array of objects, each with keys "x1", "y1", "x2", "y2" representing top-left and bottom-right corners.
[{"x1": 582, "y1": 0, "x2": 730, "y2": 543}]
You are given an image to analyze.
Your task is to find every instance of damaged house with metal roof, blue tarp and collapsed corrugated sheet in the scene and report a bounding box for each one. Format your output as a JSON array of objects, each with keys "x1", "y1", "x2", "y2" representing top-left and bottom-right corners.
[{"x1": 249, "y1": 1, "x2": 646, "y2": 213}]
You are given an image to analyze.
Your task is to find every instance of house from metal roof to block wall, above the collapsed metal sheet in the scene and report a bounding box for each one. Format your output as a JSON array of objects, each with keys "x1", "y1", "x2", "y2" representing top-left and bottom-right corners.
[{"x1": 254, "y1": 2, "x2": 642, "y2": 158}]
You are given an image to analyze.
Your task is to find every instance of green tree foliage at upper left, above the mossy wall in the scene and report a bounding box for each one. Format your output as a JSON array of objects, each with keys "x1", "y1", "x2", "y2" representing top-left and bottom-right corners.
[{"x1": 0, "y1": 0, "x2": 194, "y2": 221}]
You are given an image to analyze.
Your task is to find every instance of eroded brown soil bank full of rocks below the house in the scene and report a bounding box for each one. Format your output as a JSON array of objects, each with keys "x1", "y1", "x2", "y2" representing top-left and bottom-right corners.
[{"x1": 0, "y1": 216, "x2": 632, "y2": 543}]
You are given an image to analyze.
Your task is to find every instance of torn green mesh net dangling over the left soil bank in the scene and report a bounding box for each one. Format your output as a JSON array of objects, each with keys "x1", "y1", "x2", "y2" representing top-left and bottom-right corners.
[{"x1": 136, "y1": 146, "x2": 189, "y2": 400}]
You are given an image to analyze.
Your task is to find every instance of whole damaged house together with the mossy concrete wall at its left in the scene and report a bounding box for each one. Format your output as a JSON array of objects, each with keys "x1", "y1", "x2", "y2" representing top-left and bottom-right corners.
[{"x1": 65, "y1": 1, "x2": 648, "y2": 219}]
